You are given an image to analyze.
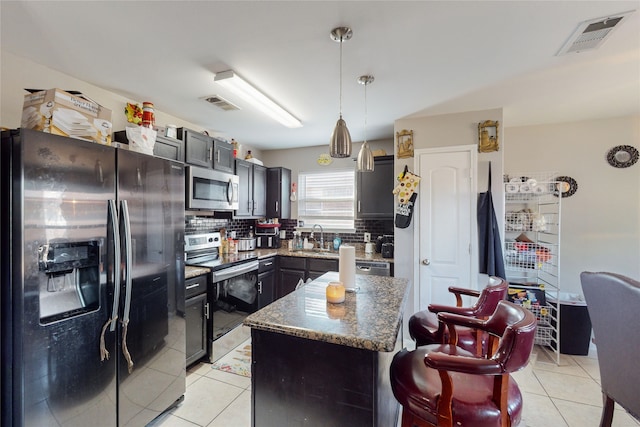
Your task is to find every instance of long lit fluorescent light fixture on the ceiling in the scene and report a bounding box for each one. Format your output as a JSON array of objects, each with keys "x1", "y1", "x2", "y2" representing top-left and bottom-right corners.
[{"x1": 214, "y1": 70, "x2": 302, "y2": 128}]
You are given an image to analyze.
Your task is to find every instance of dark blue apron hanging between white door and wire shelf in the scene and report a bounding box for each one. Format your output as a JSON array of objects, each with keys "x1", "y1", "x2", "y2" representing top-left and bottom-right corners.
[{"x1": 478, "y1": 162, "x2": 506, "y2": 279}]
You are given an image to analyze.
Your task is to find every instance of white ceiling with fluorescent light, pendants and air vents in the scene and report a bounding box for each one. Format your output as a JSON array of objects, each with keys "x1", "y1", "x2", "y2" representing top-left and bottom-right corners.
[{"x1": 0, "y1": 1, "x2": 640, "y2": 149}]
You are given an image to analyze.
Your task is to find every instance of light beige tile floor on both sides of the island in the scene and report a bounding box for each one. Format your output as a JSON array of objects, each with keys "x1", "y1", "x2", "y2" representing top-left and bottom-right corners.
[{"x1": 152, "y1": 347, "x2": 640, "y2": 427}]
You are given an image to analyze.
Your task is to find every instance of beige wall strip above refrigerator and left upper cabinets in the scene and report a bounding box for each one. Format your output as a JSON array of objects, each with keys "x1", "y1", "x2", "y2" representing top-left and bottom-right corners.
[{"x1": 0, "y1": 50, "x2": 261, "y2": 157}]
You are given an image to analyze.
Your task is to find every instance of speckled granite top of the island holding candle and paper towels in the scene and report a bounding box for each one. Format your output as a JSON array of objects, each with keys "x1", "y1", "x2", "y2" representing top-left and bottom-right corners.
[{"x1": 244, "y1": 271, "x2": 411, "y2": 352}]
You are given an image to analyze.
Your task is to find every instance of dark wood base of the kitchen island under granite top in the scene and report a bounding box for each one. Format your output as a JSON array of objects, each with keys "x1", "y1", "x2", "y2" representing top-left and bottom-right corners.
[{"x1": 251, "y1": 329, "x2": 402, "y2": 427}]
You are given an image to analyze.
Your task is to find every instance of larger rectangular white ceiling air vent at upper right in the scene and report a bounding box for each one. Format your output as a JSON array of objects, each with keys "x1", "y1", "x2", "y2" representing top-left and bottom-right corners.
[{"x1": 557, "y1": 11, "x2": 634, "y2": 56}]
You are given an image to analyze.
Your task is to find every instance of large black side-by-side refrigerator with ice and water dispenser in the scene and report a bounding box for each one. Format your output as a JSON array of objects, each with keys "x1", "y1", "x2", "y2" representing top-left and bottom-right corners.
[{"x1": 0, "y1": 130, "x2": 185, "y2": 427}]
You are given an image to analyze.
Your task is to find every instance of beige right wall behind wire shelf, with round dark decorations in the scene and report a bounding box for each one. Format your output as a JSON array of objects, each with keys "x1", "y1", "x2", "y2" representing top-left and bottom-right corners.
[{"x1": 504, "y1": 116, "x2": 640, "y2": 294}]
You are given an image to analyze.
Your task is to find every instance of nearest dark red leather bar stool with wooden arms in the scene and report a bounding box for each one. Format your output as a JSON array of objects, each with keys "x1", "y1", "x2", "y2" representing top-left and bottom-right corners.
[{"x1": 390, "y1": 301, "x2": 536, "y2": 427}]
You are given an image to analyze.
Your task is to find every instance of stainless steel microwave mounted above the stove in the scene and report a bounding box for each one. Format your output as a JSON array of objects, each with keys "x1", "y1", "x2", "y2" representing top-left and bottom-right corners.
[{"x1": 185, "y1": 166, "x2": 240, "y2": 211}]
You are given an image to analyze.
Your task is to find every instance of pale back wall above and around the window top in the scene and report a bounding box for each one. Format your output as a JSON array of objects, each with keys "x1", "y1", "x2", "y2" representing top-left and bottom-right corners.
[{"x1": 260, "y1": 139, "x2": 393, "y2": 218}]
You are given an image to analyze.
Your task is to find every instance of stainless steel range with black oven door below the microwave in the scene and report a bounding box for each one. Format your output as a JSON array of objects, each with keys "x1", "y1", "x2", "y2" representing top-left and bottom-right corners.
[{"x1": 185, "y1": 232, "x2": 258, "y2": 363}]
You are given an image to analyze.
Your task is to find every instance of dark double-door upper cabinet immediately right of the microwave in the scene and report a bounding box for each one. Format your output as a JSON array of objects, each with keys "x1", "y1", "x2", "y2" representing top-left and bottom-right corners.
[{"x1": 235, "y1": 159, "x2": 267, "y2": 218}]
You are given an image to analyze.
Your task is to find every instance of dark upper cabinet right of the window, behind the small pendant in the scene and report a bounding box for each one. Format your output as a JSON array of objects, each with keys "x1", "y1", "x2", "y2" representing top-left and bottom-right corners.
[{"x1": 356, "y1": 156, "x2": 395, "y2": 219}]
